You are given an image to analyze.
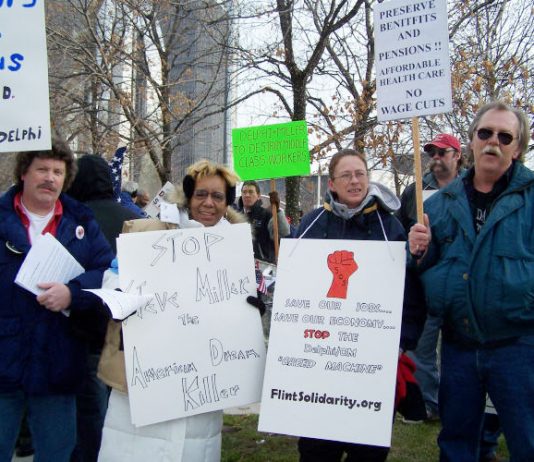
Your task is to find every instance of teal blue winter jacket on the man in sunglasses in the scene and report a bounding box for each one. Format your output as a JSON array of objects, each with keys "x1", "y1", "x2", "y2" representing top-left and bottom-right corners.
[{"x1": 419, "y1": 162, "x2": 534, "y2": 344}]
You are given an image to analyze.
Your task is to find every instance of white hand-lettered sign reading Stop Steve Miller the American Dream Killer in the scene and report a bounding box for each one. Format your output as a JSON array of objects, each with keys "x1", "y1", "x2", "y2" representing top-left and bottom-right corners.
[{"x1": 117, "y1": 223, "x2": 265, "y2": 426}]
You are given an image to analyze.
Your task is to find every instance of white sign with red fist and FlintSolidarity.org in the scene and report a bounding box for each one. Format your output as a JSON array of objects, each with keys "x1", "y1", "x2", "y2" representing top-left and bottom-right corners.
[{"x1": 258, "y1": 239, "x2": 406, "y2": 446}]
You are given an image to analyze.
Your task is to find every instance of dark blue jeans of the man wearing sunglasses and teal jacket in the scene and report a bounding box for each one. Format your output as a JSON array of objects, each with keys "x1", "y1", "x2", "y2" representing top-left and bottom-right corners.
[{"x1": 438, "y1": 337, "x2": 534, "y2": 462}]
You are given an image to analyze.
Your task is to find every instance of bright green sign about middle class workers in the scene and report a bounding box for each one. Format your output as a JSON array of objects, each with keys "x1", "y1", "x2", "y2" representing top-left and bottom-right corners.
[{"x1": 232, "y1": 120, "x2": 310, "y2": 181}]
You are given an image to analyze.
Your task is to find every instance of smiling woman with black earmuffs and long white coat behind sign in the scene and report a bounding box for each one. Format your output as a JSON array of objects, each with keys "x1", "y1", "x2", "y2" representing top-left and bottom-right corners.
[{"x1": 99, "y1": 160, "x2": 265, "y2": 462}]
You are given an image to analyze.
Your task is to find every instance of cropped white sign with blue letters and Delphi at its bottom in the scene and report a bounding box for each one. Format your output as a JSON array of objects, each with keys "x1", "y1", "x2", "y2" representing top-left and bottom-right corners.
[{"x1": 0, "y1": 0, "x2": 51, "y2": 152}]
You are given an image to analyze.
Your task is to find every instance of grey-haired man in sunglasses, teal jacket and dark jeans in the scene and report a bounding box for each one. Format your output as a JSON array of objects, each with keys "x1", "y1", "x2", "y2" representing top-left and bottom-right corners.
[{"x1": 409, "y1": 102, "x2": 534, "y2": 462}]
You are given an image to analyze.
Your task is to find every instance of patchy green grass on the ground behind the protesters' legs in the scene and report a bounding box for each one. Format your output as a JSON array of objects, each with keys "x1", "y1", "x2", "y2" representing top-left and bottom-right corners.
[{"x1": 222, "y1": 414, "x2": 507, "y2": 462}]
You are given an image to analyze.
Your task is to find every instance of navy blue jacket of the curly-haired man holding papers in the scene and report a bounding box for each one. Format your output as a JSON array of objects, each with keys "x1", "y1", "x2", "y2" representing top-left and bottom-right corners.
[{"x1": 0, "y1": 187, "x2": 113, "y2": 394}]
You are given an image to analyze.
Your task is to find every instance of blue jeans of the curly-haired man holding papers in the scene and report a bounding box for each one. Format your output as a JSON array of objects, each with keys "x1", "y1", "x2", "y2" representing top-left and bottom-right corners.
[{"x1": 0, "y1": 391, "x2": 76, "y2": 462}]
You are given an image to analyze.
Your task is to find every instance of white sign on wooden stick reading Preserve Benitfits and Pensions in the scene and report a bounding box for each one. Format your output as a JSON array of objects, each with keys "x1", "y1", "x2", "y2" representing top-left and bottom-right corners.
[{"x1": 374, "y1": 0, "x2": 452, "y2": 122}]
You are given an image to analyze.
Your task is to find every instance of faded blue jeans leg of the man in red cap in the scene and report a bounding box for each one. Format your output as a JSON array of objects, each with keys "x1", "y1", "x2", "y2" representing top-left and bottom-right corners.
[{"x1": 407, "y1": 315, "x2": 441, "y2": 414}]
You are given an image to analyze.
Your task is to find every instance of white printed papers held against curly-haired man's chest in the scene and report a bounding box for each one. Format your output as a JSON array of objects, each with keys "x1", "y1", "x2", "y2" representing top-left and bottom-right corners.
[{"x1": 15, "y1": 233, "x2": 85, "y2": 295}]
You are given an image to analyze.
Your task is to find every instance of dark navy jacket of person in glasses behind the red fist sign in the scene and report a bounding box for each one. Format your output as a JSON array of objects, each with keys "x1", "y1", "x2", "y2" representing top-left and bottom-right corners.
[{"x1": 297, "y1": 192, "x2": 426, "y2": 350}]
